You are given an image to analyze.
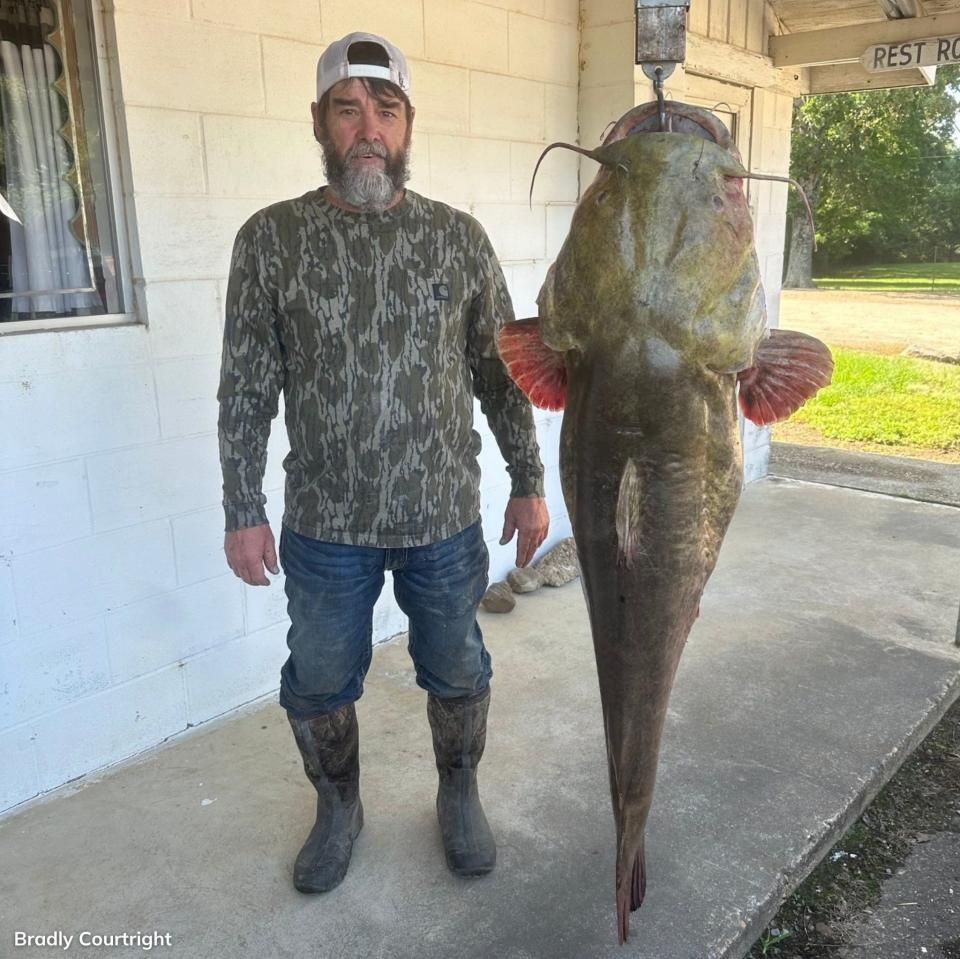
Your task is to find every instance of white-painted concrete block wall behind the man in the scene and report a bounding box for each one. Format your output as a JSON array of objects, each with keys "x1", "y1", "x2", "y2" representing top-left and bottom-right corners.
[{"x1": 0, "y1": 0, "x2": 579, "y2": 810}]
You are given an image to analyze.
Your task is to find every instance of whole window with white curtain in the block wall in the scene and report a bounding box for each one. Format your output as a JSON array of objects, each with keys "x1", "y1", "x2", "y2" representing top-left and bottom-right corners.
[{"x1": 0, "y1": 0, "x2": 129, "y2": 334}]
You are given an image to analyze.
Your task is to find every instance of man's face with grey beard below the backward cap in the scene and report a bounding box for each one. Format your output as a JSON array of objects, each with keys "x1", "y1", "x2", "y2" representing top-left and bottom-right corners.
[{"x1": 311, "y1": 78, "x2": 413, "y2": 212}]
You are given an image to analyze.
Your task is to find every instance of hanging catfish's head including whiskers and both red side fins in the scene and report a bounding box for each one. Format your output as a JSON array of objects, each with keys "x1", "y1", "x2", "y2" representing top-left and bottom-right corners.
[{"x1": 499, "y1": 101, "x2": 833, "y2": 426}]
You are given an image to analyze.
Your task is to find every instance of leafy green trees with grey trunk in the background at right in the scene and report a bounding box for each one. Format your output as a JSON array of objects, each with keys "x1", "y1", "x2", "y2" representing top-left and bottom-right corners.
[{"x1": 784, "y1": 66, "x2": 960, "y2": 286}]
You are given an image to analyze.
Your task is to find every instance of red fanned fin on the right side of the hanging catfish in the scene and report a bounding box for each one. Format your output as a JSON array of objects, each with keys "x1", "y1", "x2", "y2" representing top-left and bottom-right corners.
[{"x1": 737, "y1": 330, "x2": 833, "y2": 426}]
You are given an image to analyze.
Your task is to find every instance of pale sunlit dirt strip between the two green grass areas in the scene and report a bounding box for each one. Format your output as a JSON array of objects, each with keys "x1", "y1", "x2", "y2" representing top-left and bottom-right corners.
[{"x1": 780, "y1": 290, "x2": 960, "y2": 355}]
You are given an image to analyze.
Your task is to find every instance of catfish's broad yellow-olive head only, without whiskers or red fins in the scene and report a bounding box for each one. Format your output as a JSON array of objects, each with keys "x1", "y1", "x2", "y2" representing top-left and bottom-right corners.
[{"x1": 538, "y1": 121, "x2": 766, "y2": 372}]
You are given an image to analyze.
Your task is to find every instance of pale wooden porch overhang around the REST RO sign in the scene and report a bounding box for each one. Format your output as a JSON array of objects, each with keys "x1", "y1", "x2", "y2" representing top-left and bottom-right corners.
[{"x1": 767, "y1": 0, "x2": 960, "y2": 93}]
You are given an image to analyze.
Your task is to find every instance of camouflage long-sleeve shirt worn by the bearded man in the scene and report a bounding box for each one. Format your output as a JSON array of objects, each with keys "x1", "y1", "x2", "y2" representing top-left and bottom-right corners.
[{"x1": 217, "y1": 188, "x2": 543, "y2": 547}]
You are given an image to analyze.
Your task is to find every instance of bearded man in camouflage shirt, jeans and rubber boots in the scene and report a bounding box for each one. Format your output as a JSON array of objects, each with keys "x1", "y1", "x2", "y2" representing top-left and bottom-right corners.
[{"x1": 218, "y1": 33, "x2": 549, "y2": 892}]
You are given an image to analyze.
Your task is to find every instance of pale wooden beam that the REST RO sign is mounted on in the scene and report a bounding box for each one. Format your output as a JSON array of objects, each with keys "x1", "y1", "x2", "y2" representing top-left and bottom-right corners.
[{"x1": 770, "y1": 13, "x2": 960, "y2": 67}]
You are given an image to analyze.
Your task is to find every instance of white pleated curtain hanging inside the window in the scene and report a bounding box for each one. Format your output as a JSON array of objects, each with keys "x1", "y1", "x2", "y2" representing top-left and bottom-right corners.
[{"x1": 0, "y1": 40, "x2": 100, "y2": 316}]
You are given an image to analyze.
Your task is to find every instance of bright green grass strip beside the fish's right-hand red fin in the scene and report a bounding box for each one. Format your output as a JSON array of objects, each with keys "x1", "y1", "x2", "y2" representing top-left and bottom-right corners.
[{"x1": 773, "y1": 348, "x2": 960, "y2": 463}]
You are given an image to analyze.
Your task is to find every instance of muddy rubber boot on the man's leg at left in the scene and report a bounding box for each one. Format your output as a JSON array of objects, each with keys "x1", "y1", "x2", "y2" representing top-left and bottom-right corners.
[{"x1": 288, "y1": 703, "x2": 363, "y2": 892}]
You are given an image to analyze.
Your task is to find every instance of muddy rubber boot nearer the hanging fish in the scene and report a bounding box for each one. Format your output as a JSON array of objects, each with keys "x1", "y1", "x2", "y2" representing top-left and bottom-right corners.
[{"x1": 427, "y1": 687, "x2": 497, "y2": 876}]
